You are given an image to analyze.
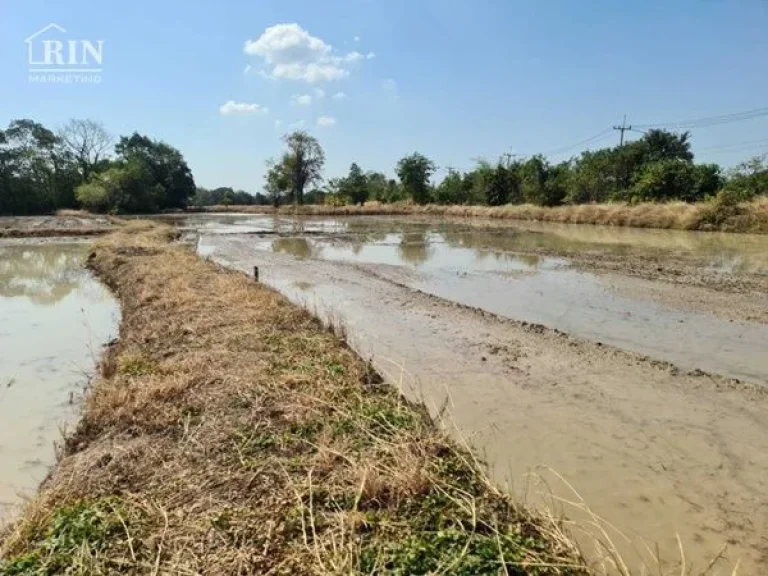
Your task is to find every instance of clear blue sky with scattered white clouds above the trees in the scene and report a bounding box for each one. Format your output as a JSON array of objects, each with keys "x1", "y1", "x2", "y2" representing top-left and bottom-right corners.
[{"x1": 0, "y1": 0, "x2": 768, "y2": 192}]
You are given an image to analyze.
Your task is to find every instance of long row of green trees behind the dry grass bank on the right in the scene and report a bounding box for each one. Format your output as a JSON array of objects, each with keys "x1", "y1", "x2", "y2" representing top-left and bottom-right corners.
[{"x1": 264, "y1": 130, "x2": 768, "y2": 206}]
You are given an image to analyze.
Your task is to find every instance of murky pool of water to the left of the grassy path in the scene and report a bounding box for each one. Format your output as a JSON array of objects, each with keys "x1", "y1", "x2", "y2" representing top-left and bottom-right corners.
[{"x1": 0, "y1": 242, "x2": 119, "y2": 523}]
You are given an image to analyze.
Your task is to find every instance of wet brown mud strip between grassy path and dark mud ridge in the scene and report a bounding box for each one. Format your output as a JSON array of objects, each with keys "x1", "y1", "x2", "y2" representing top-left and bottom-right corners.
[{"x1": 200, "y1": 236, "x2": 768, "y2": 575}]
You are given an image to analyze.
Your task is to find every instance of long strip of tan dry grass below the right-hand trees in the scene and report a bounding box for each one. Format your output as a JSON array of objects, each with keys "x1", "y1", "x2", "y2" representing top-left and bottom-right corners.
[{"x1": 196, "y1": 197, "x2": 768, "y2": 234}]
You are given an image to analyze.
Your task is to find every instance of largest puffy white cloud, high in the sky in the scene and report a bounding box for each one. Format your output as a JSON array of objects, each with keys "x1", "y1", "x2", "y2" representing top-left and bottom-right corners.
[{"x1": 243, "y1": 23, "x2": 373, "y2": 84}]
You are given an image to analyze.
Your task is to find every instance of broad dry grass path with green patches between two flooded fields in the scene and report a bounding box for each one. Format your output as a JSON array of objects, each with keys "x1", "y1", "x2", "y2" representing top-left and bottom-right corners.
[{"x1": 0, "y1": 222, "x2": 586, "y2": 574}]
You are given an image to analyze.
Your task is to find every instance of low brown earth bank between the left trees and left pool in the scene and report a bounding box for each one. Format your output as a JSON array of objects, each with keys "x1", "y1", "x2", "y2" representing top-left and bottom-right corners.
[{"x1": 0, "y1": 211, "x2": 116, "y2": 238}]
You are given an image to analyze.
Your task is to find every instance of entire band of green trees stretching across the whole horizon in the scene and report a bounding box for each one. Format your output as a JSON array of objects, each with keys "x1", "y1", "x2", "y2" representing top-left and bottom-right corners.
[{"x1": 0, "y1": 119, "x2": 768, "y2": 214}]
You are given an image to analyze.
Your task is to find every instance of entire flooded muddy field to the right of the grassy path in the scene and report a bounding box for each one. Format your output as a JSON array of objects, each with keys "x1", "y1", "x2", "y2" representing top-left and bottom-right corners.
[{"x1": 182, "y1": 216, "x2": 768, "y2": 574}]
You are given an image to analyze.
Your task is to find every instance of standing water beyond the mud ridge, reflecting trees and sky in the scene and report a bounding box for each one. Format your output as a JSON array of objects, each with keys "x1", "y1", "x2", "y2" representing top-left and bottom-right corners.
[{"x1": 185, "y1": 216, "x2": 768, "y2": 384}]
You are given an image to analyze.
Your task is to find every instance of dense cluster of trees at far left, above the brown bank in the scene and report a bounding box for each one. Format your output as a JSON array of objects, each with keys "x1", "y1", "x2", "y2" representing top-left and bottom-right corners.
[{"x1": 0, "y1": 119, "x2": 196, "y2": 215}]
